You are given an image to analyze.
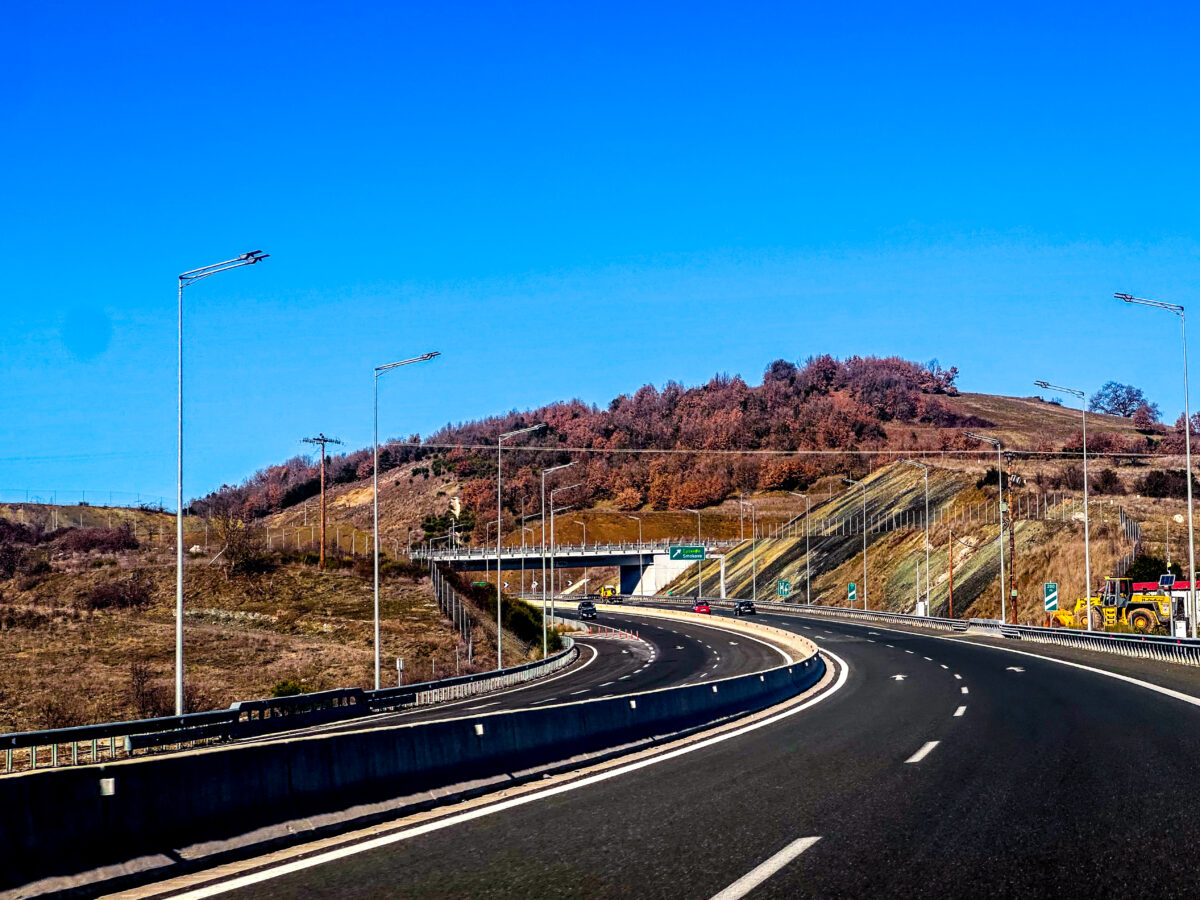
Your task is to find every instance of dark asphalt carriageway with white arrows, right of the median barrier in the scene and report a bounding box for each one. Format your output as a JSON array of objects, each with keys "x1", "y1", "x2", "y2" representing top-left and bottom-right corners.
[{"x1": 150, "y1": 614, "x2": 1200, "y2": 898}]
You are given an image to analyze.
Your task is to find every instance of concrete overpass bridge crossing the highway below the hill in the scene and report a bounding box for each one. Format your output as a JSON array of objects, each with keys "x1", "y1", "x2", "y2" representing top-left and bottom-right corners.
[{"x1": 412, "y1": 540, "x2": 739, "y2": 596}]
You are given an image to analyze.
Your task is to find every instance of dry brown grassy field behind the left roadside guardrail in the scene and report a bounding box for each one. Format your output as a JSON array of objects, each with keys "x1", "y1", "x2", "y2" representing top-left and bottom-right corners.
[{"x1": 0, "y1": 551, "x2": 468, "y2": 731}]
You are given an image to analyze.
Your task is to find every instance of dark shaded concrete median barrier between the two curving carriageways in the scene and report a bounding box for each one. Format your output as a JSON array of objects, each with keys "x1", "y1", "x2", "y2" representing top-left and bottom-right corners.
[{"x1": 0, "y1": 628, "x2": 824, "y2": 888}]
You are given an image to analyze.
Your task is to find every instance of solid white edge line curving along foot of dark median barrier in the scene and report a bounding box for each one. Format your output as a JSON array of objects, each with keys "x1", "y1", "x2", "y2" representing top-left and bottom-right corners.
[{"x1": 172, "y1": 650, "x2": 850, "y2": 900}]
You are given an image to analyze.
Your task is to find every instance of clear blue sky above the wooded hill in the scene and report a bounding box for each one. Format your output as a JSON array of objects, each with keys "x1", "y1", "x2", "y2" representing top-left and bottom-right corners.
[{"x1": 0, "y1": 2, "x2": 1200, "y2": 497}]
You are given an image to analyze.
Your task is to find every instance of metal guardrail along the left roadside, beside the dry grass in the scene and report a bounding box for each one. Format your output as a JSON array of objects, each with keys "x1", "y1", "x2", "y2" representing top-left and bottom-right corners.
[{"x1": 0, "y1": 637, "x2": 578, "y2": 774}]
